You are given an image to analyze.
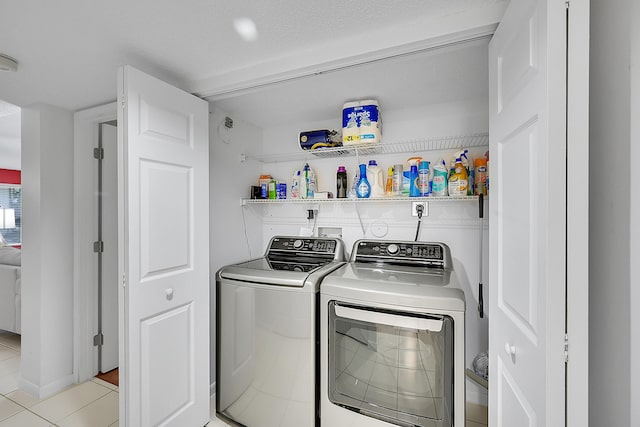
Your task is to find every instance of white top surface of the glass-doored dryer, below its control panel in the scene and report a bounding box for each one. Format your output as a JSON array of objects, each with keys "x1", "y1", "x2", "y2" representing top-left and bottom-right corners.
[{"x1": 320, "y1": 263, "x2": 465, "y2": 311}]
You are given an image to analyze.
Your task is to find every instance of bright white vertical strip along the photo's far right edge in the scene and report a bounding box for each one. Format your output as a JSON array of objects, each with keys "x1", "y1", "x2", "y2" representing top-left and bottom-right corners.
[{"x1": 628, "y1": 1, "x2": 640, "y2": 426}]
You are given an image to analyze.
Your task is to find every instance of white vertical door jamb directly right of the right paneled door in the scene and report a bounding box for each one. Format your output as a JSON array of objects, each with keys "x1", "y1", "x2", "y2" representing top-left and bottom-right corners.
[{"x1": 565, "y1": 1, "x2": 590, "y2": 427}]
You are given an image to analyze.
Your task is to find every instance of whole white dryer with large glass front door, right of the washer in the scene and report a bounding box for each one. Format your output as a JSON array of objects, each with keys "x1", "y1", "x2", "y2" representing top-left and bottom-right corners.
[{"x1": 319, "y1": 240, "x2": 465, "y2": 427}]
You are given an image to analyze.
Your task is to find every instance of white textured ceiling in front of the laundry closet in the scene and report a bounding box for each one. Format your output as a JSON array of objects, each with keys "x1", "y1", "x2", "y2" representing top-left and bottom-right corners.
[{"x1": 0, "y1": 0, "x2": 507, "y2": 111}]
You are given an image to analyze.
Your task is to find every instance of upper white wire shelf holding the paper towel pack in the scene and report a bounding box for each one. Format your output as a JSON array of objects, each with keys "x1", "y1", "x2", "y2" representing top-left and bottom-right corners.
[{"x1": 245, "y1": 133, "x2": 489, "y2": 163}]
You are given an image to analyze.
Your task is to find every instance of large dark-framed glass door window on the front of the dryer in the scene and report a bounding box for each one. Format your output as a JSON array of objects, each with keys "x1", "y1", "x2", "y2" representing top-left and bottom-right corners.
[{"x1": 328, "y1": 301, "x2": 454, "y2": 427}]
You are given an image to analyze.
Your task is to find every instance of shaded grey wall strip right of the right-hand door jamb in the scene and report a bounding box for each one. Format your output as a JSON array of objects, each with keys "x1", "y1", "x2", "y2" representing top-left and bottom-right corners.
[{"x1": 589, "y1": 0, "x2": 638, "y2": 426}]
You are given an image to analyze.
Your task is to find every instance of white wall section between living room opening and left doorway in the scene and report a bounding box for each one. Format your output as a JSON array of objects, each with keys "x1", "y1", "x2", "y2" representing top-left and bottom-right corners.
[{"x1": 20, "y1": 104, "x2": 74, "y2": 397}]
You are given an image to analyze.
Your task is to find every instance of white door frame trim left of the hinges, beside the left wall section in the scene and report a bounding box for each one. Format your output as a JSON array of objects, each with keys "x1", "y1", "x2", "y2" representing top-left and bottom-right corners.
[{"x1": 73, "y1": 102, "x2": 117, "y2": 383}]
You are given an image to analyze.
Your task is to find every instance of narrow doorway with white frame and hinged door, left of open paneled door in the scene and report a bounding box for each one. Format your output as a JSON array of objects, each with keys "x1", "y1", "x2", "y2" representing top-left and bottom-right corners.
[{"x1": 74, "y1": 103, "x2": 118, "y2": 383}]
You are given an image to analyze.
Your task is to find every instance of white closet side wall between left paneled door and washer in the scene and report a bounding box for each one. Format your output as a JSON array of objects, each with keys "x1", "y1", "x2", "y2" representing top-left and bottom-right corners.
[{"x1": 209, "y1": 106, "x2": 264, "y2": 392}]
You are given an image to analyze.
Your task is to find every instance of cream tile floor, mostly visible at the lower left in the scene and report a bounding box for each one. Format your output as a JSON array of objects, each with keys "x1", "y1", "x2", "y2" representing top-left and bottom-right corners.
[{"x1": 0, "y1": 331, "x2": 487, "y2": 427}]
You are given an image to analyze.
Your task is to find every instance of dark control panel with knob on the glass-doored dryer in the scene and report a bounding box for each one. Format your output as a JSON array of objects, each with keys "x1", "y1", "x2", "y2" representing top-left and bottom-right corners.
[{"x1": 351, "y1": 240, "x2": 453, "y2": 270}]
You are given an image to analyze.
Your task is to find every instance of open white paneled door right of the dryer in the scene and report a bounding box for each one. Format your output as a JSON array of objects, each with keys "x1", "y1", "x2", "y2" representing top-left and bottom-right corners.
[{"x1": 489, "y1": 0, "x2": 588, "y2": 427}]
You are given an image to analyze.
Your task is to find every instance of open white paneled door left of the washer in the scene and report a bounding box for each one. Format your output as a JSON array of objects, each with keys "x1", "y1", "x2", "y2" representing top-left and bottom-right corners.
[{"x1": 118, "y1": 66, "x2": 209, "y2": 427}]
